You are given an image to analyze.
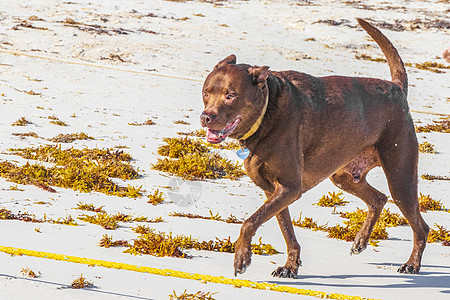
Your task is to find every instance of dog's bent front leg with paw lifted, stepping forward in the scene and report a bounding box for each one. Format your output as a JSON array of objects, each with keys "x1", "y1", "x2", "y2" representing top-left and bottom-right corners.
[{"x1": 234, "y1": 182, "x2": 301, "y2": 275}]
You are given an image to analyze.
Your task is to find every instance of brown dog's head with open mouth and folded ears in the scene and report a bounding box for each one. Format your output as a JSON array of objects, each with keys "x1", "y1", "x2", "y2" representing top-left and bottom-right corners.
[{"x1": 200, "y1": 55, "x2": 269, "y2": 143}]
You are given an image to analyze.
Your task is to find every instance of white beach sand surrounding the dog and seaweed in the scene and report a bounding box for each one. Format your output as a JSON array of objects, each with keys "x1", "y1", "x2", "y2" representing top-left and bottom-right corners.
[{"x1": 0, "y1": 0, "x2": 450, "y2": 299}]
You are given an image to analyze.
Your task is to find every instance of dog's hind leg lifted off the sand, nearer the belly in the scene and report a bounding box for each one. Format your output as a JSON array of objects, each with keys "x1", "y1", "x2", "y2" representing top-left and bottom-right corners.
[{"x1": 330, "y1": 167, "x2": 387, "y2": 254}]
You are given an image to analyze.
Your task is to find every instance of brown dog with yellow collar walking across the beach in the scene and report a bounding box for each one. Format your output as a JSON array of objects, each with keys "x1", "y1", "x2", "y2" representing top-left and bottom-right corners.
[{"x1": 200, "y1": 19, "x2": 429, "y2": 278}]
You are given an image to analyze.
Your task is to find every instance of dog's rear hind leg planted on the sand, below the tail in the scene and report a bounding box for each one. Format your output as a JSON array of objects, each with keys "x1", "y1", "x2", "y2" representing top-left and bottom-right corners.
[{"x1": 377, "y1": 126, "x2": 429, "y2": 274}]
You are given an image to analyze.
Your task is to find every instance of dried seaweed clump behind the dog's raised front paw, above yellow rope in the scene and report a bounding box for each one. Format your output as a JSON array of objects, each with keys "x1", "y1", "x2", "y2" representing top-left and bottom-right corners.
[{"x1": 124, "y1": 226, "x2": 279, "y2": 258}]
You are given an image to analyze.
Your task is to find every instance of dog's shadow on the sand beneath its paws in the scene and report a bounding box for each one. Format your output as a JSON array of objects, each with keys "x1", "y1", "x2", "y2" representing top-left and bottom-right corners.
[{"x1": 268, "y1": 263, "x2": 450, "y2": 294}]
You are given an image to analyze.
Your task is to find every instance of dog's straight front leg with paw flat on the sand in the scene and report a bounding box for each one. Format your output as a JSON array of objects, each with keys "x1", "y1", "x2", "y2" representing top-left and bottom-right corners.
[{"x1": 272, "y1": 208, "x2": 302, "y2": 278}]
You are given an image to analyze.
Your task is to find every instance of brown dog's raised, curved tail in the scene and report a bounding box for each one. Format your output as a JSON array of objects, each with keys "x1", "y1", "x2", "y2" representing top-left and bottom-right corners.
[{"x1": 356, "y1": 18, "x2": 408, "y2": 94}]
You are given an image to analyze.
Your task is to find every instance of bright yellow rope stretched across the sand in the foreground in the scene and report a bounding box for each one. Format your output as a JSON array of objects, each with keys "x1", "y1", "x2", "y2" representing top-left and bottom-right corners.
[{"x1": 0, "y1": 246, "x2": 373, "y2": 300}]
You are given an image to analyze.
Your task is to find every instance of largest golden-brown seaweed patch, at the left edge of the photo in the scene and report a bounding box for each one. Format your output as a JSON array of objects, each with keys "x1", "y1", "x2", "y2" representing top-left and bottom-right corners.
[{"x1": 0, "y1": 145, "x2": 142, "y2": 198}]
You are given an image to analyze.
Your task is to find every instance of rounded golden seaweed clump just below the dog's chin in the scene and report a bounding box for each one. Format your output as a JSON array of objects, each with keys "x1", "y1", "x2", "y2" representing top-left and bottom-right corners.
[{"x1": 152, "y1": 137, "x2": 245, "y2": 180}]
